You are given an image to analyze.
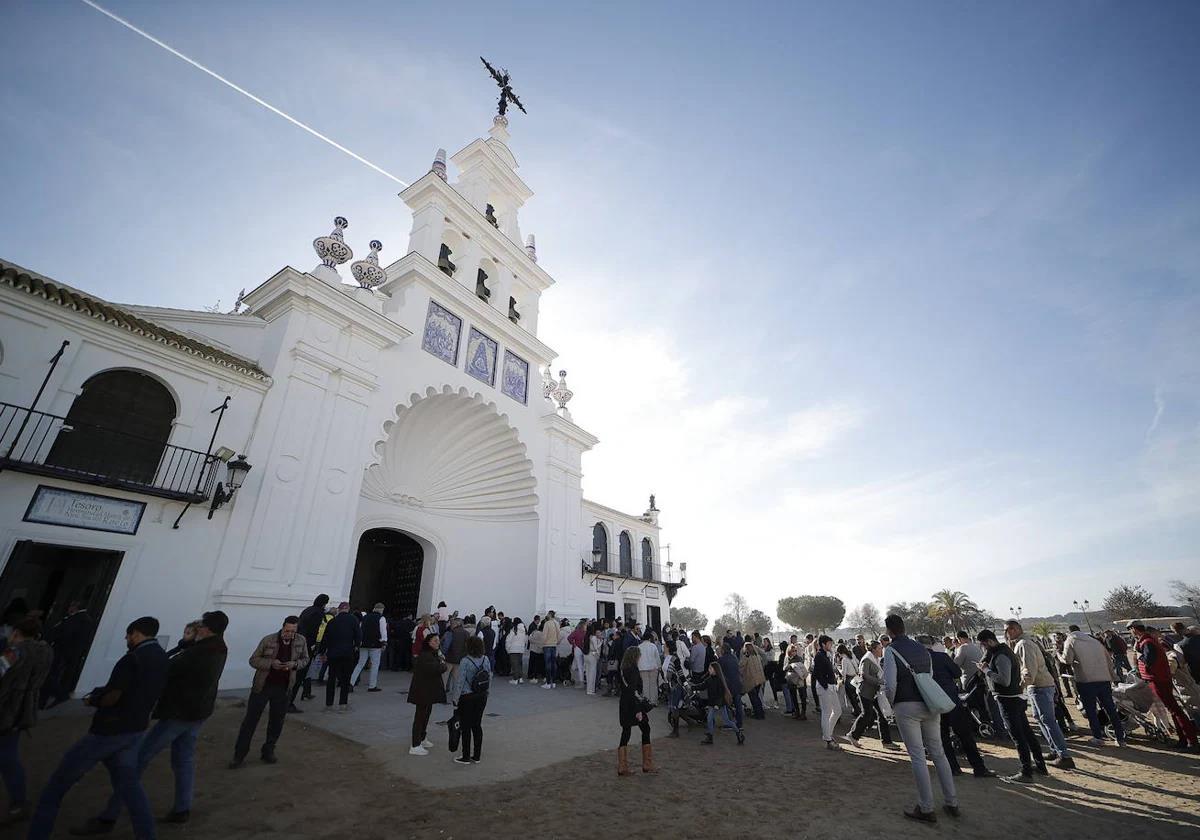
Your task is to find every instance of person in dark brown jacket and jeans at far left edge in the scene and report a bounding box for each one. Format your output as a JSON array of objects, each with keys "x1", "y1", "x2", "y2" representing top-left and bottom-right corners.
[{"x1": 0, "y1": 617, "x2": 54, "y2": 827}]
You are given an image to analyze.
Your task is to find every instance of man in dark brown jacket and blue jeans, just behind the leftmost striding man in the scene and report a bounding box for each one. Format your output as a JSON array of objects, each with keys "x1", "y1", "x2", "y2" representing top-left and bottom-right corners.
[{"x1": 72, "y1": 610, "x2": 229, "y2": 835}]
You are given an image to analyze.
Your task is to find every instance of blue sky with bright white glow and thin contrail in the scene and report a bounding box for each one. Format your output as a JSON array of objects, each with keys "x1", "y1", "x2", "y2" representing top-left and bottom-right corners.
[{"x1": 0, "y1": 0, "x2": 1200, "y2": 616}]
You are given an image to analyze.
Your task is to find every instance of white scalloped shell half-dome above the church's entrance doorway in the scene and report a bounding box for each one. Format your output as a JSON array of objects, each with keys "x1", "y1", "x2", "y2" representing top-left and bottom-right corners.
[{"x1": 362, "y1": 388, "x2": 538, "y2": 521}]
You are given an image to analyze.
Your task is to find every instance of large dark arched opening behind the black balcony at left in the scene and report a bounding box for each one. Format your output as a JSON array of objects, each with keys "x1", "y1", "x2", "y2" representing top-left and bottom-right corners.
[{"x1": 46, "y1": 370, "x2": 178, "y2": 485}]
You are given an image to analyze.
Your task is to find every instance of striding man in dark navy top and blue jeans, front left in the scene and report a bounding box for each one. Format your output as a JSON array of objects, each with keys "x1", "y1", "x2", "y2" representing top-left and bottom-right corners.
[{"x1": 29, "y1": 616, "x2": 167, "y2": 840}]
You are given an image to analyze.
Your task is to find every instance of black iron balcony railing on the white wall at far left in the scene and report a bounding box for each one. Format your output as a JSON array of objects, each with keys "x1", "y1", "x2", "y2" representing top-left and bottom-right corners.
[{"x1": 0, "y1": 402, "x2": 217, "y2": 502}]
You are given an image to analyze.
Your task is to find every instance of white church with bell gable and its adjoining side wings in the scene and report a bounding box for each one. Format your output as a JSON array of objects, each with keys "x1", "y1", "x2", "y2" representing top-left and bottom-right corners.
[{"x1": 0, "y1": 111, "x2": 684, "y2": 688}]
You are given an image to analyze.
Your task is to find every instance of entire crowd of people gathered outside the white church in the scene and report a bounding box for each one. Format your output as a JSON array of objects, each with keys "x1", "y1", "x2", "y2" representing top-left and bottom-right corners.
[{"x1": 0, "y1": 595, "x2": 1200, "y2": 840}]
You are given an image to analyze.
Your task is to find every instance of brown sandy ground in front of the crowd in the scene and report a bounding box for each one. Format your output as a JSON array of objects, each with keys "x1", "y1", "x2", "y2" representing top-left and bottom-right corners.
[{"x1": 11, "y1": 695, "x2": 1200, "y2": 840}]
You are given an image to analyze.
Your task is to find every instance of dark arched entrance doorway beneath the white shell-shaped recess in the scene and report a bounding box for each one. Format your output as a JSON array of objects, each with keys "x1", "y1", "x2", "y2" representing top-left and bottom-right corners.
[{"x1": 350, "y1": 528, "x2": 425, "y2": 616}]
